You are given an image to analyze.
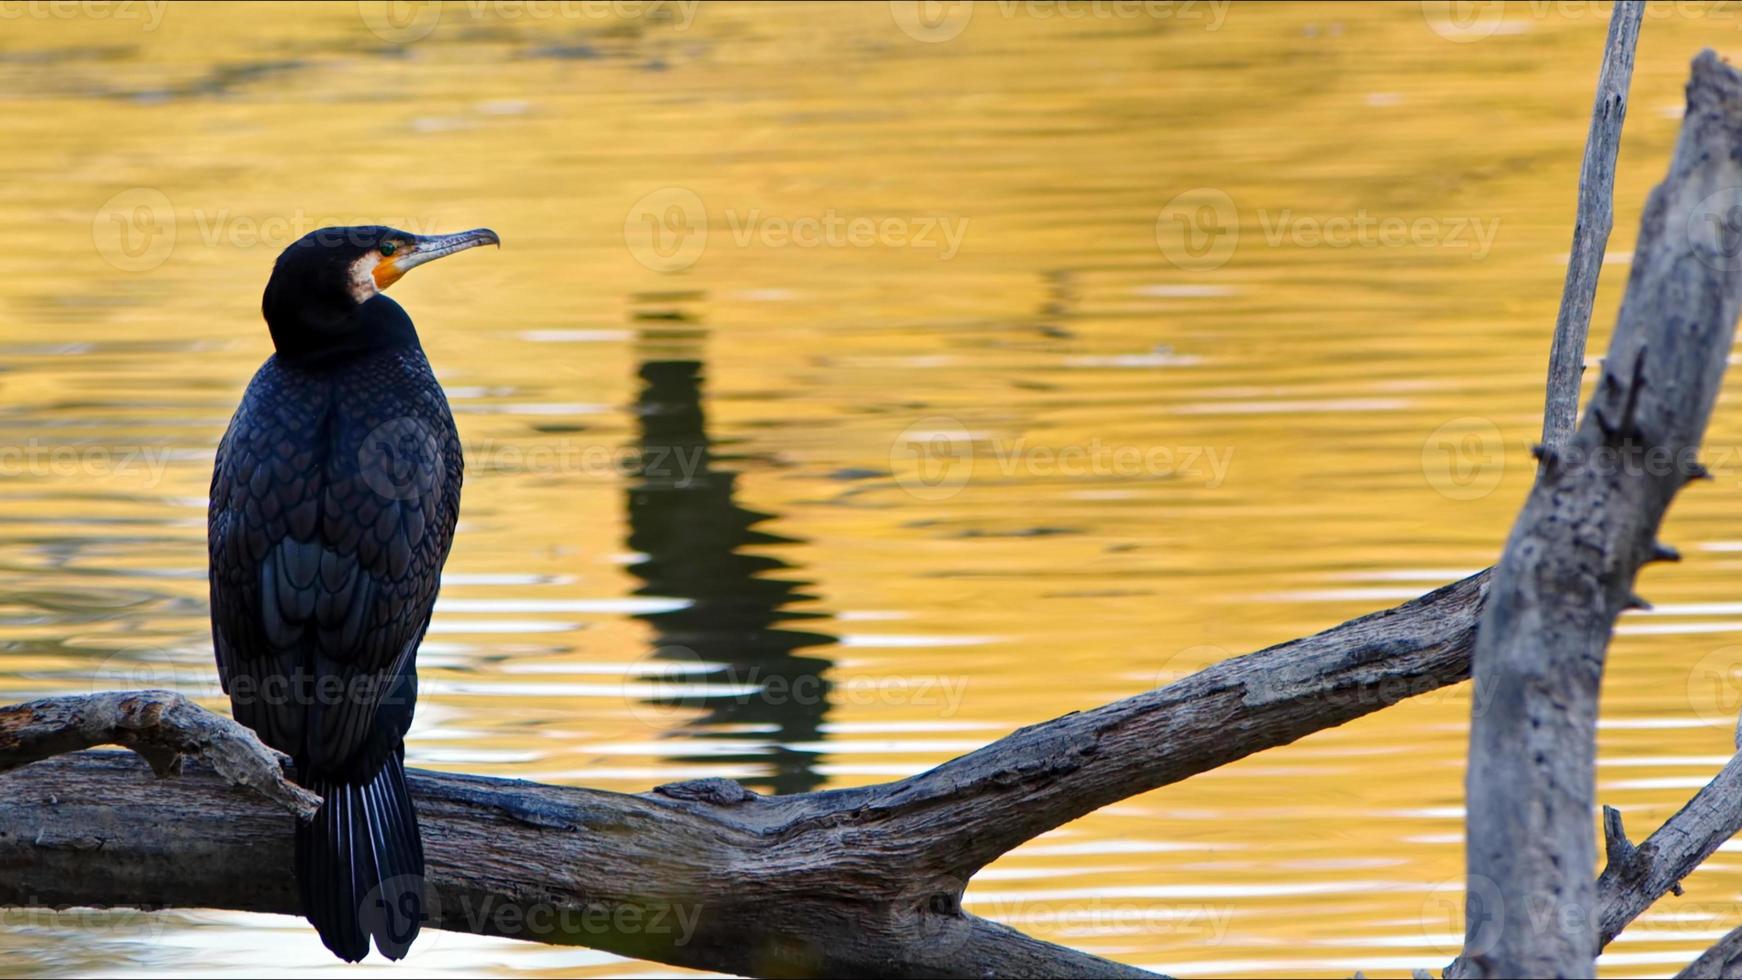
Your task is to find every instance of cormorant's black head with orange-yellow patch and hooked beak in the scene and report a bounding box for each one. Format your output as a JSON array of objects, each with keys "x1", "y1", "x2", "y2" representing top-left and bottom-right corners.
[{"x1": 261, "y1": 225, "x2": 502, "y2": 360}]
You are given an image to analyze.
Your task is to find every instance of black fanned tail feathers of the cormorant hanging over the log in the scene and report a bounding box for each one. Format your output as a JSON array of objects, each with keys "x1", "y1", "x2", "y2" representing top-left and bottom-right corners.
[{"x1": 296, "y1": 755, "x2": 423, "y2": 963}]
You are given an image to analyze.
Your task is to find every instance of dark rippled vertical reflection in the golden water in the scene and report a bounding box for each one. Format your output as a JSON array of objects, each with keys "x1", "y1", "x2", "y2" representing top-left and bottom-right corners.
[{"x1": 629, "y1": 334, "x2": 834, "y2": 794}]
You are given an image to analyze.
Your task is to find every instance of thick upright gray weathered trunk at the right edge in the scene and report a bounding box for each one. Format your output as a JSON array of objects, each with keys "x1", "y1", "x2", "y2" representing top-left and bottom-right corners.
[{"x1": 1463, "y1": 52, "x2": 1742, "y2": 977}]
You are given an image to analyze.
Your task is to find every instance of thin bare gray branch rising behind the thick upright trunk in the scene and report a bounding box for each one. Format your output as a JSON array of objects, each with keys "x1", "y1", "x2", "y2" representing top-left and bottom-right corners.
[{"x1": 1542, "y1": 0, "x2": 1644, "y2": 453}]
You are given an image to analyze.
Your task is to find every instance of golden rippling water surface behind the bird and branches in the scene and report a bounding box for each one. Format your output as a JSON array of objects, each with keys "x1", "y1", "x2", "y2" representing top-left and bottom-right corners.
[{"x1": 0, "y1": 2, "x2": 1742, "y2": 977}]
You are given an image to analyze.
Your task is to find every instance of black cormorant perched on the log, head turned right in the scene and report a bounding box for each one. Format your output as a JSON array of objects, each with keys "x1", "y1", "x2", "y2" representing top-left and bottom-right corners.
[{"x1": 207, "y1": 226, "x2": 500, "y2": 961}]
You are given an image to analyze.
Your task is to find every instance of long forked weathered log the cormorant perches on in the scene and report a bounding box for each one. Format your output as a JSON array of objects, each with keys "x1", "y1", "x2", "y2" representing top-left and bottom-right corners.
[{"x1": 0, "y1": 573, "x2": 1488, "y2": 977}]
